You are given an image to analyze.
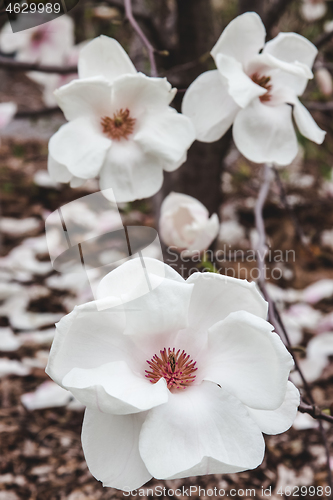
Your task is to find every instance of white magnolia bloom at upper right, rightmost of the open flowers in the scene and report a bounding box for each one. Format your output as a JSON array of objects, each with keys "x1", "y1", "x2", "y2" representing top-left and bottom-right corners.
[{"x1": 182, "y1": 12, "x2": 325, "y2": 165}]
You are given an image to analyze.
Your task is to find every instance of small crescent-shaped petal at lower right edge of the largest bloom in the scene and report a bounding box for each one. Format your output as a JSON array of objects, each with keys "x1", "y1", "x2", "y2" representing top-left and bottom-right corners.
[{"x1": 248, "y1": 382, "x2": 300, "y2": 434}]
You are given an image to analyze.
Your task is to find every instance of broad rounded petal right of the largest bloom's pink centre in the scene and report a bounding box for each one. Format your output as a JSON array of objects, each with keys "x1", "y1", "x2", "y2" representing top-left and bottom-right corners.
[{"x1": 202, "y1": 311, "x2": 293, "y2": 410}]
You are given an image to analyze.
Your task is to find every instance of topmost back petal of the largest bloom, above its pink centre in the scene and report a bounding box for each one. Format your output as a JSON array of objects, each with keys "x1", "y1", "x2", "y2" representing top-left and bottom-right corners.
[{"x1": 94, "y1": 258, "x2": 193, "y2": 360}]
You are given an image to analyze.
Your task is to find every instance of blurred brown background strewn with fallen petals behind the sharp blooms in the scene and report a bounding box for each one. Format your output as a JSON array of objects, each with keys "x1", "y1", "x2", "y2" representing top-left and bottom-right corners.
[{"x1": 0, "y1": 0, "x2": 333, "y2": 500}]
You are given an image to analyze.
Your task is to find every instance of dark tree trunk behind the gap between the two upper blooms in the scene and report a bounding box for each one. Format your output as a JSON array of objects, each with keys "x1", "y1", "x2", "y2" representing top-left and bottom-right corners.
[{"x1": 163, "y1": 0, "x2": 230, "y2": 219}]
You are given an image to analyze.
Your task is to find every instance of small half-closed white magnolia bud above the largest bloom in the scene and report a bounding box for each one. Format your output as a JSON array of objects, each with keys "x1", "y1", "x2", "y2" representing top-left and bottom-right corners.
[{"x1": 159, "y1": 193, "x2": 219, "y2": 256}]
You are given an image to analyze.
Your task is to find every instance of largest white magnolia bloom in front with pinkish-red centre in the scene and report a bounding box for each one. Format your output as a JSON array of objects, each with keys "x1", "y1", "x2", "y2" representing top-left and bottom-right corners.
[{"x1": 47, "y1": 258, "x2": 299, "y2": 490}]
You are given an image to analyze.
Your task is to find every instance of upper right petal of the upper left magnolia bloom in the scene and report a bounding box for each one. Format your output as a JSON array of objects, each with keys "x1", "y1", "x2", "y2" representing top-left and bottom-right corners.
[{"x1": 112, "y1": 73, "x2": 177, "y2": 112}]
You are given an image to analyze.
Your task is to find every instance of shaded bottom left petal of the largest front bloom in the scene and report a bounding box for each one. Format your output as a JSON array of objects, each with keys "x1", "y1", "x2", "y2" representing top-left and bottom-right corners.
[{"x1": 82, "y1": 409, "x2": 151, "y2": 491}]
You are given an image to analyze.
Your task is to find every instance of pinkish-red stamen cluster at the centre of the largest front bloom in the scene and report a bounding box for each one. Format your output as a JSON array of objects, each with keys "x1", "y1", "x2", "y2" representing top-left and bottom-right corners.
[{"x1": 145, "y1": 348, "x2": 197, "y2": 389}]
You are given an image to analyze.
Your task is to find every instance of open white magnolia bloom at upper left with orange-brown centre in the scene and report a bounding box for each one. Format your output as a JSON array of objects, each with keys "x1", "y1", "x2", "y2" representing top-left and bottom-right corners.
[{"x1": 48, "y1": 36, "x2": 195, "y2": 202}]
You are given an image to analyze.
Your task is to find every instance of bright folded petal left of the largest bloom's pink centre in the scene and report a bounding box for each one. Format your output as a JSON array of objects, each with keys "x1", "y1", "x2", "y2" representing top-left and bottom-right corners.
[{"x1": 63, "y1": 361, "x2": 169, "y2": 415}]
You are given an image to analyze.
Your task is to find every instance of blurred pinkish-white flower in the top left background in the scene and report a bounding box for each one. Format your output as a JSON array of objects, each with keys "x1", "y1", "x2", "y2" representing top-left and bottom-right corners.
[{"x1": 0, "y1": 16, "x2": 74, "y2": 65}]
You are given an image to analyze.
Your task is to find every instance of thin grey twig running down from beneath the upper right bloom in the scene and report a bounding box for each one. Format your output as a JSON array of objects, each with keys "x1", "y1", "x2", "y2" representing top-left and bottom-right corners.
[{"x1": 254, "y1": 164, "x2": 333, "y2": 491}]
